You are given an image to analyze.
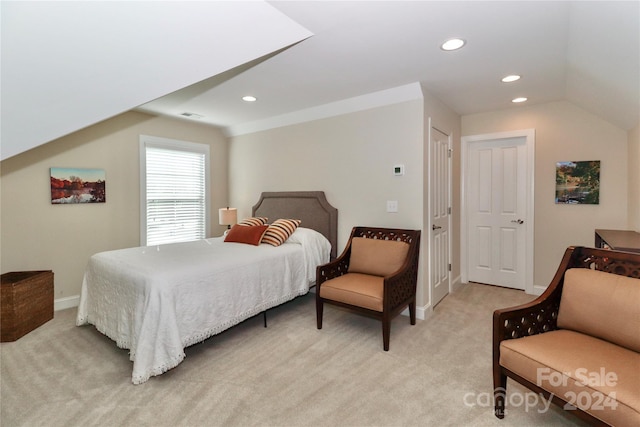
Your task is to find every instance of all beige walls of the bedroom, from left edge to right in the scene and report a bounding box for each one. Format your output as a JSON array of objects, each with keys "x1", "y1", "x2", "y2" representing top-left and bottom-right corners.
[{"x1": 0, "y1": 95, "x2": 628, "y2": 307}]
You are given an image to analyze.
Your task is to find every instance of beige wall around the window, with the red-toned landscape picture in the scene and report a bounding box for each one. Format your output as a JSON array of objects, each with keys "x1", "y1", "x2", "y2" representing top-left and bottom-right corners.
[{"x1": 0, "y1": 112, "x2": 227, "y2": 300}]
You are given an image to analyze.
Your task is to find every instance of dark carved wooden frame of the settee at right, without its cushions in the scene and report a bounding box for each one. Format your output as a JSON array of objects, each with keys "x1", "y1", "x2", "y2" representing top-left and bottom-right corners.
[{"x1": 493, "y1": 247, "x2": 640, "y2": 425}]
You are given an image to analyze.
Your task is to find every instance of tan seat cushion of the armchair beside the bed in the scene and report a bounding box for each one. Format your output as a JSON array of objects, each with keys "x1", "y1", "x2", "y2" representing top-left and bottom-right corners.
[{"x1": 320, "y1": 273, "x2": 384, "y2": 312}]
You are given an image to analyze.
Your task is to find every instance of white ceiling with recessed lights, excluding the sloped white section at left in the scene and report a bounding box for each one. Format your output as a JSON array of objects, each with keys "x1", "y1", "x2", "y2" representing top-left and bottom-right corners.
[{"x1": 140, "y1": 1, "x2": 640, "y2": 134}]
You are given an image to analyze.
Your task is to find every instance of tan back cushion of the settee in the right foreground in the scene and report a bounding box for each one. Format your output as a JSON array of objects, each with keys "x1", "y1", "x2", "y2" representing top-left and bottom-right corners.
[{"x1": 558, "y1": 268, "x2": 640, "y2": 352}]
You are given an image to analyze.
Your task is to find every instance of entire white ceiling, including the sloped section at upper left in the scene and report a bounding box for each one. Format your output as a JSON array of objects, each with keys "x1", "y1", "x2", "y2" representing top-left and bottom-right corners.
[{"x1": 2, "y1": 1, "x2": 640, "y2": 159}]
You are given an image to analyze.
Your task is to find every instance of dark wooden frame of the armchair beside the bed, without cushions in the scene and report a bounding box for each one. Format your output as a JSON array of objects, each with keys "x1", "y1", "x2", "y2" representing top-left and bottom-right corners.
[{"x1": 316, "y1": 227, "x2": 420, "y2": 351}]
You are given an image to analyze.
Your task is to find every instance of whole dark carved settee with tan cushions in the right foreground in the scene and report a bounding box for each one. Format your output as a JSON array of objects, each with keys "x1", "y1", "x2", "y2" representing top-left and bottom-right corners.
[{"x1": 493, "y1": 246, "x2": 640, "y2": 427}]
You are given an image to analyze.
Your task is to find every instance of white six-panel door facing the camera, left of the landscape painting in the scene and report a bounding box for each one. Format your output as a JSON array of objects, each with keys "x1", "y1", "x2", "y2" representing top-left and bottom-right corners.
[{"x1": 463, "y1": 137, "x2": 533, "y2": 290}]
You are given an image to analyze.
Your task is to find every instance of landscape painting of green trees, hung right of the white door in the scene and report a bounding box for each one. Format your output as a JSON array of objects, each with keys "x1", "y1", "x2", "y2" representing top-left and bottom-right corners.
[{"x1": 556, "y1": 160, "x2": 600, "y2": 205}]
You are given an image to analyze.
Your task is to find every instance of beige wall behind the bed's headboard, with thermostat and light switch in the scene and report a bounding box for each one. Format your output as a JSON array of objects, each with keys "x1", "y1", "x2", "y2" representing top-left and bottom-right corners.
[{"x1": 229, "y1": 100, "x2": 428, "y2": 306}]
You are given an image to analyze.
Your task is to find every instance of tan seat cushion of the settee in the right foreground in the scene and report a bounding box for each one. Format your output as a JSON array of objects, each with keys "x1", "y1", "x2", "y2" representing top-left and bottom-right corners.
[{"x1": 500, "y1": 330, "x2": 640, "y2": 426}]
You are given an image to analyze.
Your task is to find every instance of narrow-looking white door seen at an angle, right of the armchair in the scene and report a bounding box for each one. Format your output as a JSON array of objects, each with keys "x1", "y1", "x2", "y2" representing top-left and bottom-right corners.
[{"x1": 428, "y1": 126, "x2": 451, "y2": 306}]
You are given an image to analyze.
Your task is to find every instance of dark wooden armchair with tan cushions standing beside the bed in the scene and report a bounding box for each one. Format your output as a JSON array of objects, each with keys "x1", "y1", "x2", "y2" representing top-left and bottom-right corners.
[{"x1": 316, "y1": 227, "x2": 420, "y2": 351}]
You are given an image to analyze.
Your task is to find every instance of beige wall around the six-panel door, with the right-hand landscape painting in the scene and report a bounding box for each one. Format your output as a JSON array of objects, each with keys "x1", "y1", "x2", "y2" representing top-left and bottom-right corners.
[{"x1": 462, "y1": 102, "x2": 629, "y2": 287}]
